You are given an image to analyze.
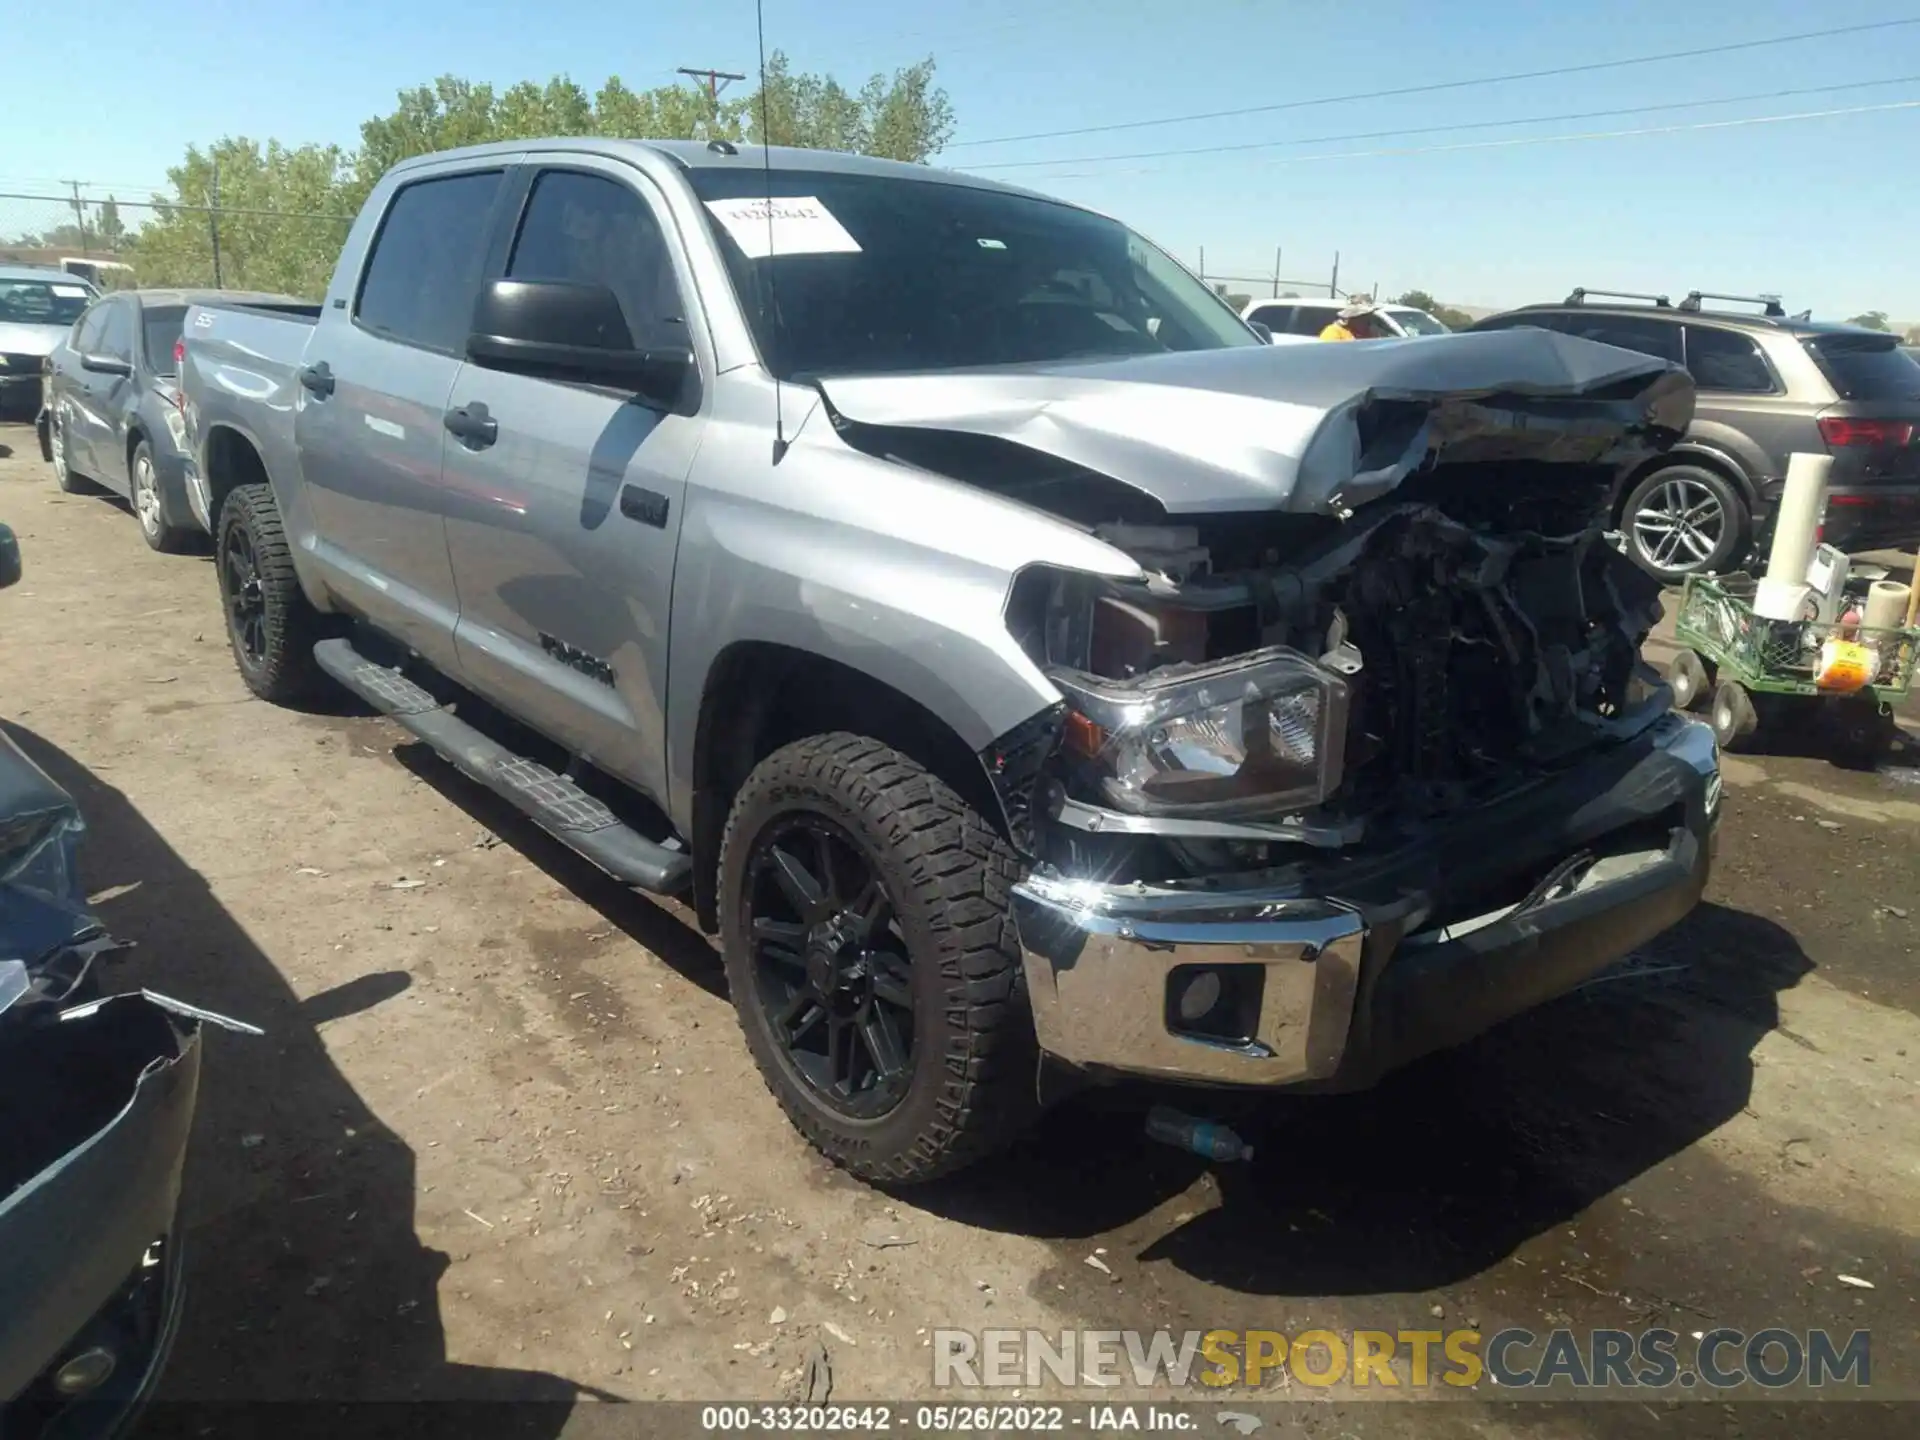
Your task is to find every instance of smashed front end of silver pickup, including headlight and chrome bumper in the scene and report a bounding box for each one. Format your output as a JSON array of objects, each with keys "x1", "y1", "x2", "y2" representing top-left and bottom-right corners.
[{"x1": 898, "y1": 338, "x2": 1718, "y2": 1087}]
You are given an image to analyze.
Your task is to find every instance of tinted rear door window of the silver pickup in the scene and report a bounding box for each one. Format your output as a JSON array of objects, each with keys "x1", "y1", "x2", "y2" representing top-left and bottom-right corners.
[{"x1": 353, "y1": 171, "x2": 503, "y2": 355}]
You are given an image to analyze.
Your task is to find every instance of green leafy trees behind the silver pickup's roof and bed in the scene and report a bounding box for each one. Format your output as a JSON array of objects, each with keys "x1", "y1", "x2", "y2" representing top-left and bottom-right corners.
[{"x1": 116, "y1": 54, "x2": 954, "y2": 296}]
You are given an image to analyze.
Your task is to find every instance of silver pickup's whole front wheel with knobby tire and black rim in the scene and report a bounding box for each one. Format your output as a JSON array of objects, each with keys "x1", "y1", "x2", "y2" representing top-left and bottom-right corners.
[{"x1": 720, "y1": 733, "x2": 1037, "y2": 1185}]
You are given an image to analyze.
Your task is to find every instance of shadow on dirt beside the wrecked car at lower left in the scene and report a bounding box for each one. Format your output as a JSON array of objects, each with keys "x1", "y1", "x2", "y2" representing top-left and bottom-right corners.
[{"x1": 6, "y1": 726, "x2": 597, "y2": 1436}]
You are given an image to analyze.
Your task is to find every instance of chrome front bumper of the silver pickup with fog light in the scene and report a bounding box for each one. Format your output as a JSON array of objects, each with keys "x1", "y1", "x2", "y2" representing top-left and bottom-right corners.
[{"x1": 1014, "y1": 714, "x2": 1720, "y2": 1089}]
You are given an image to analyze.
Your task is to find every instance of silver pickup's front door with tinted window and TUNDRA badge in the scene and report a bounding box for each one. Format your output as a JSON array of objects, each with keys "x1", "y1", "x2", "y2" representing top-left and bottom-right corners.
[{"x1": 445, "y1": 156, "x2": 712, "y2": 803}]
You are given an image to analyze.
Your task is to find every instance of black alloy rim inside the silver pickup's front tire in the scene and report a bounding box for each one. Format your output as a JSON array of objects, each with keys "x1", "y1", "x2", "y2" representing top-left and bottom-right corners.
[{"x1": 743, "y1": 810, "x2": 914, "y2": 1119}]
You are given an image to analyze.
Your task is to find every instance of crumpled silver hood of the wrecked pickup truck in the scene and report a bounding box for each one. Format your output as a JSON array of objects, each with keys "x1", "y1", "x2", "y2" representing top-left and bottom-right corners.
[{"x1": 818, "y1": 326, "x2": 1693, "y2": 515}]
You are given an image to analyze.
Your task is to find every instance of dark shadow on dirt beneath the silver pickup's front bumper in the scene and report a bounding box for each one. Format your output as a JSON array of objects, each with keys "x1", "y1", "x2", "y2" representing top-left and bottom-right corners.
[{"x1": 910, "y1": 904, "x2": 1812, "y2": 1296}]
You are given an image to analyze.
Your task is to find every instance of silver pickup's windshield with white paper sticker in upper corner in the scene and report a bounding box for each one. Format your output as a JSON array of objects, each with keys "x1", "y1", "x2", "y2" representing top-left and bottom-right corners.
[{"x1": 689, "y1": 169, "x2": 1261, "y2": 380}]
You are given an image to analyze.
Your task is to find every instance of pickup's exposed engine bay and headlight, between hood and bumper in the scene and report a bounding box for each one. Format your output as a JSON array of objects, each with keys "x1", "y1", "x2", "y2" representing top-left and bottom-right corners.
[{"x1": 1012, "y1": 461, "x2": 1665, "y2": 874}]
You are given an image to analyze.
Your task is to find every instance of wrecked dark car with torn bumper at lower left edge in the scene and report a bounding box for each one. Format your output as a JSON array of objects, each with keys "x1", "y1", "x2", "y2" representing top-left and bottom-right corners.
[{"x1": 0, "y1": 733, "x2": 234, "y2": 1440}]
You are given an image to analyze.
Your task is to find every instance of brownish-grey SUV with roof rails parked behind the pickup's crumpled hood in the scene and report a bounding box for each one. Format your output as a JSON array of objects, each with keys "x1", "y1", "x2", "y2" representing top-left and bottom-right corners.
[{"x1": 1473, "y1": 290, "x2": 1920, "y2": 582}]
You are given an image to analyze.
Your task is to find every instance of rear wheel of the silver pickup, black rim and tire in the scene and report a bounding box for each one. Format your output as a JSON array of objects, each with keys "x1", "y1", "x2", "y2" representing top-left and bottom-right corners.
[{"x1": 215, "y1": 484, "x2": 326, "y2": 705}]
